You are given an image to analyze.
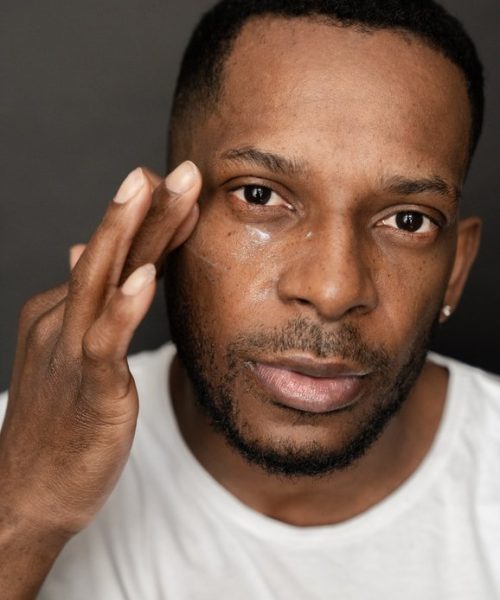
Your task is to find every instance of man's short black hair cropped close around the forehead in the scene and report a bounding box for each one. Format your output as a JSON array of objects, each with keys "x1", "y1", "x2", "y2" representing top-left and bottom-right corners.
[{"x1": 171, "y1": 0, "x2": 484, "y2": 164}]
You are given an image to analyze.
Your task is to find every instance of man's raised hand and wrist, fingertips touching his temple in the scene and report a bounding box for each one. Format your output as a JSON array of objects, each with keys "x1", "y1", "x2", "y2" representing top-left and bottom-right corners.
[{"x1": 0, "y1": 162, "x2": 201, "y2": 600}]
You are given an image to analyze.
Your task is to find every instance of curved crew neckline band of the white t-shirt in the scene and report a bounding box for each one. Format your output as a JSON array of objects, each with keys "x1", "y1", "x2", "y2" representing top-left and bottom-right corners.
[{"x1": 156, "y1": 345, "x2": 468, "y2": 544}]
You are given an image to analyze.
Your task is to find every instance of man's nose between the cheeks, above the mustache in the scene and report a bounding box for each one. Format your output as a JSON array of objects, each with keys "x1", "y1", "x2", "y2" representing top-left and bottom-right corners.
[{"x1": 277, "y1": 222, "x2": 378, "y2": 321}]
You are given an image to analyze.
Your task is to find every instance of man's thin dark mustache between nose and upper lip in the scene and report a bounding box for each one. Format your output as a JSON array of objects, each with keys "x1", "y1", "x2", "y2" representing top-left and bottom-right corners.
[{"x1": 228, "y1": 317, "x2": 391, "y2": 371}]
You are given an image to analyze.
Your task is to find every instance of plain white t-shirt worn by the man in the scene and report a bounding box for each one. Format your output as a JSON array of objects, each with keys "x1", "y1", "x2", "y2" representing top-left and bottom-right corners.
[{"x1": 0, "y1": 345, "x2": 500, "y2": 600}]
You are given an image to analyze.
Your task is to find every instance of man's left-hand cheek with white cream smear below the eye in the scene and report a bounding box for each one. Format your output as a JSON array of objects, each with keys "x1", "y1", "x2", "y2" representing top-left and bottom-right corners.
[{"x1": 182, "y1": 210, "x2": 290, "y2": 337}]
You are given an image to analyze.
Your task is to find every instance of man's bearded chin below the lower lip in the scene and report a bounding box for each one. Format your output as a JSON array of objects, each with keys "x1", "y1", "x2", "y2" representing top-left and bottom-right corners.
[{"x1": 206, "y1": 384, "x2": 406, "y2": 477}]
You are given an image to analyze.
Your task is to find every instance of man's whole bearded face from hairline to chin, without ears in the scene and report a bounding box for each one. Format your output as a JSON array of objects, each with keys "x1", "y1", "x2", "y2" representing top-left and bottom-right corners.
[{"x1": 167, "y1": 19, "x2": 469, "y2": 474}]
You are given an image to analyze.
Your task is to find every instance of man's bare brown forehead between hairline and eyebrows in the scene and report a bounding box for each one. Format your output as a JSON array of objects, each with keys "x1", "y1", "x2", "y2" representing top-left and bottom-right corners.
[{"x1": 198, "y1": 17, "x2": 470, "y2": 180}]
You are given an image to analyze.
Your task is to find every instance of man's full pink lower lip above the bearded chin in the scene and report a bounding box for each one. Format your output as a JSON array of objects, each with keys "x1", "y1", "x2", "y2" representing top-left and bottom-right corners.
[{"x1": 253, "y1": 363, "x2": 362, "y2": 414}]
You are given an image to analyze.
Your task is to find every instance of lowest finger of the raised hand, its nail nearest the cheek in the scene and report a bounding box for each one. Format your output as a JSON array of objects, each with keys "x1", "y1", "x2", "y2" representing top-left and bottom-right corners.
[{"x1": 83, "y1": 264, "x2": 156, "y2": 399}]
